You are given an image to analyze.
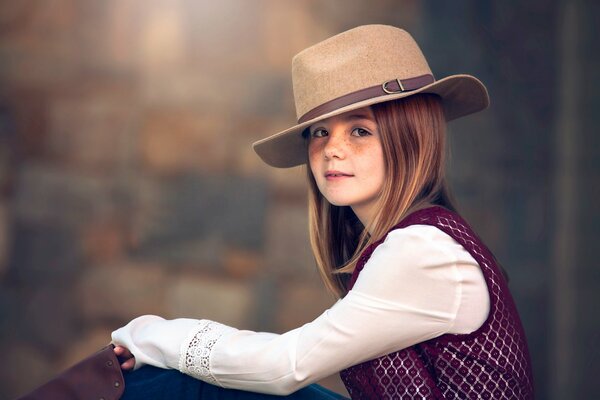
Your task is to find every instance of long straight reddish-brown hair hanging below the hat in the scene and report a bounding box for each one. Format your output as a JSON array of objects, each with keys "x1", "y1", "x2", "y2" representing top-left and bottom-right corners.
[{"x1": 307, "y1": 94, "x2": 456, "y2": 297}]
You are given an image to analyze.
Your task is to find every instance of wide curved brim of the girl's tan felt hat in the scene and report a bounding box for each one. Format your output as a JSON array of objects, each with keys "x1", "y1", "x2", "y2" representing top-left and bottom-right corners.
[{"x1": 252, "y1": 74, "x2": 490, "y2": 168}]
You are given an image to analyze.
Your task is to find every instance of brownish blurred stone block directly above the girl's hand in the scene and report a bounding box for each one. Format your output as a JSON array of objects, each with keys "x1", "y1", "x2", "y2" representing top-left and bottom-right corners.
[{"x1": 76, "y1": 263, "x2": 168, "y2": 323}]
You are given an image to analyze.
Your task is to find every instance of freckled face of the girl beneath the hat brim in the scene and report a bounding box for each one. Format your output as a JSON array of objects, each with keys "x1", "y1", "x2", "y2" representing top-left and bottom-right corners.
[{"x1": 308, "y1": 107, "x2": 385, "y2": 224}]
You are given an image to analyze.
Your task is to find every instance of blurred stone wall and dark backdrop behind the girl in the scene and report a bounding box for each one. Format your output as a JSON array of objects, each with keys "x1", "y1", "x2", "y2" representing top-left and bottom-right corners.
[{"x1": 0, "y1": 0, "x2": 600, "y2": 399}]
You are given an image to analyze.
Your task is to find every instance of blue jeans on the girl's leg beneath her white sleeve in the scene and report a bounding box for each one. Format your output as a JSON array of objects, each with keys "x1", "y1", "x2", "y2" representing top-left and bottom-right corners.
[{"x1": 121, "y1": 366, "x2": 346, "y2": 400}]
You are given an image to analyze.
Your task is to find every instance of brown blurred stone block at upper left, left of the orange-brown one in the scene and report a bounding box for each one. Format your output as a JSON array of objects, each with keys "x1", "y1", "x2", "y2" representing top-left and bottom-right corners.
[{"x1": 46, "y1": 79, "x2": 138, "y2": 174}]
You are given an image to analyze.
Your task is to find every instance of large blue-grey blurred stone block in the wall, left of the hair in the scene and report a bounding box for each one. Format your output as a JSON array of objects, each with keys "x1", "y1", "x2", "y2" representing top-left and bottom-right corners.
[{"x1": 133, "y1": 174, "x2": 267, "y2": 266}]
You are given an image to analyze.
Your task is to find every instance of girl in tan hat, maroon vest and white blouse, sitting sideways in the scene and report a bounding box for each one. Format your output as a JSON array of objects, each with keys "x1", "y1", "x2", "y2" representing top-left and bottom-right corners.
[{"x1": 21, "y1": 25, "x2": 533, "y2": 399}]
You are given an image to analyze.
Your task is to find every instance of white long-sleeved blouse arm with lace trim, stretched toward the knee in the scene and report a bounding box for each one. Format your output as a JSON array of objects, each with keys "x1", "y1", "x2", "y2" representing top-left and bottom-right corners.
[{"x1": 112, "y1": 225, "x2": 489, "y2": 395}]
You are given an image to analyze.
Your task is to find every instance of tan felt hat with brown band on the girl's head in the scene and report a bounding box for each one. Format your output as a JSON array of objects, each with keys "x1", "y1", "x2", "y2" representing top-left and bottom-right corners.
[{"x1": 252, "y1": 25, "x2": 489, "y2": 168}]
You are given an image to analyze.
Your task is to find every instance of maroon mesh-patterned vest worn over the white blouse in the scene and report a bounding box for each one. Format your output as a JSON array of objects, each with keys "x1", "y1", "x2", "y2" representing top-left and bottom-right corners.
[{"x1": 340, "y1": 206, "x2": 533, "y2": 399}]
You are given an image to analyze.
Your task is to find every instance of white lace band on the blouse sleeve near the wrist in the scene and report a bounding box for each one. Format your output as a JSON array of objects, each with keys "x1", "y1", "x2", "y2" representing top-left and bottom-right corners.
[{"x1": 179, "y1": 319, "x2": 236, "y2": 385}]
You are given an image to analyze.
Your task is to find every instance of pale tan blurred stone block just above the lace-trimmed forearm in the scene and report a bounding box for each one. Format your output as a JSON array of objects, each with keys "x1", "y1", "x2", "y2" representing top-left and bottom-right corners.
[{"x1": 166, "y1": 274, "x2": 255, "y2": 328}]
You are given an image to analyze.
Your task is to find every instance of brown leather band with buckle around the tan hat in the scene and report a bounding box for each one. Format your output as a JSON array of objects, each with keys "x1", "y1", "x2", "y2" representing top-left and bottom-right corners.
[{"x1": 298, "y1": 74, "x2": 435, "y2": 124}]
